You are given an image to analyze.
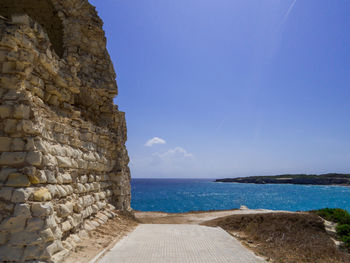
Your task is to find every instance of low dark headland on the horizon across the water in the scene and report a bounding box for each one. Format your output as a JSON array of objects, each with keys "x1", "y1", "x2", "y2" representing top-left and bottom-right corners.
[{"x1": 215, "y1": 173, "x2": 350, "y2": 185}]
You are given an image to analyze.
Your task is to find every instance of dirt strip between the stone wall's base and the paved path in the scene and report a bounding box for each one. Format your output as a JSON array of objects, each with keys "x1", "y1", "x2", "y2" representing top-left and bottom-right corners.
[{"x1": 64, "y1": 211, "x2": 138, "y2": 263}]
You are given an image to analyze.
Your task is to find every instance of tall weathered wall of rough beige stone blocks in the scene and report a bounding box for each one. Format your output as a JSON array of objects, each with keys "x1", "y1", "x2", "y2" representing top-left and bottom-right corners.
[{"x1": 0, "y1": 0, "x2": 130, "y2": 262}]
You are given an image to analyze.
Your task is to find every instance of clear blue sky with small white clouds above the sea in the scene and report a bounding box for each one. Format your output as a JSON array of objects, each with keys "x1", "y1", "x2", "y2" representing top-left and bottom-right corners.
[{"x1": 90, "y1": 0, "x2": 350, "y2": 178}]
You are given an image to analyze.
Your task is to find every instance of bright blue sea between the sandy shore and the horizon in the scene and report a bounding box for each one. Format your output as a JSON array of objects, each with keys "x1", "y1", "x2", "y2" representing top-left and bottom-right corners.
[{"x1": 131, "y1": 179, "x2": 350, "y2": 212}]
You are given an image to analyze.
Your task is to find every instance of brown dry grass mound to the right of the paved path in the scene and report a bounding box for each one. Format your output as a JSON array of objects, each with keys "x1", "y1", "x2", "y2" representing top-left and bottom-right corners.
[{"x1": 202, "y1": 213, "x2": 350, "y2": 263}]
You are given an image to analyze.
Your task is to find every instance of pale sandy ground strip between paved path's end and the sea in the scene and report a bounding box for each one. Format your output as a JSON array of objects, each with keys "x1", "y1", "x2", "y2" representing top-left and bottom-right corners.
[{"x1": 134, "y1": 209, "x2": 285, "y2": 224}]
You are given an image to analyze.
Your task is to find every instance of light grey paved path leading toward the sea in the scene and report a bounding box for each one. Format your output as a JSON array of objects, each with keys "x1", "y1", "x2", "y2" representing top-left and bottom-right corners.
[{"x1": 99, "y1": 224, "x2": 265, "y2": 263}]
